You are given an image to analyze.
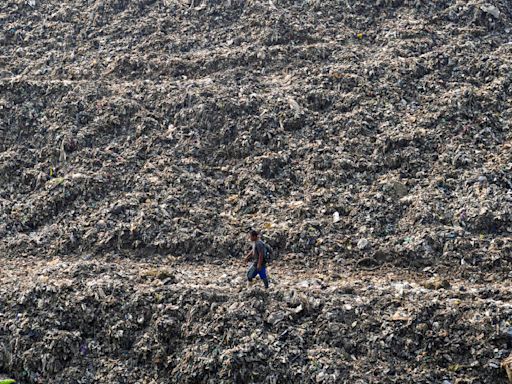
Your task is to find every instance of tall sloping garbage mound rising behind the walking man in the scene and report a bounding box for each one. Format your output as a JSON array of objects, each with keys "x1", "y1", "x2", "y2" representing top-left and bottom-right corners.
[{"x1": 0, "y1": 0, "x2": 512, "y2": 270}]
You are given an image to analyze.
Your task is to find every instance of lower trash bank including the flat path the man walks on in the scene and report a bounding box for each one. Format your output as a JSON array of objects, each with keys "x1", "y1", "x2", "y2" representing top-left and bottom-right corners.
[{"x1": 0, "y1": 259, "x2": 512, "y2": 384}]
